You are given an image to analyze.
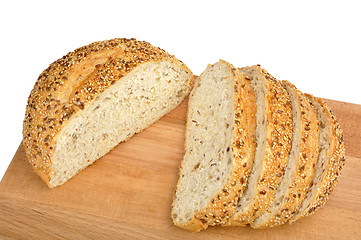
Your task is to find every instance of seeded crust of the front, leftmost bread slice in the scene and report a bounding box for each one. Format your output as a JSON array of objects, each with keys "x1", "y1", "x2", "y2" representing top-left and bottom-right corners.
[{"x1": 172, "y1": 60, "x2": 256, "y2": 232}]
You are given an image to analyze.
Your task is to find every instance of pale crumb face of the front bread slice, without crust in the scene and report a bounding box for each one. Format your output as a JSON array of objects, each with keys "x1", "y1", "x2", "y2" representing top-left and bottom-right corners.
[{"x1": 172, "y1": 61, "x2": 234, "y2": 225}]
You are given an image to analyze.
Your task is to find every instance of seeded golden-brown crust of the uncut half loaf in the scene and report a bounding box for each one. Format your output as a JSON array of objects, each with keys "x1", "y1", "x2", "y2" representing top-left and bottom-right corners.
[{"x1": 23, "y1": 38, "x2": 193, "y2": 187}]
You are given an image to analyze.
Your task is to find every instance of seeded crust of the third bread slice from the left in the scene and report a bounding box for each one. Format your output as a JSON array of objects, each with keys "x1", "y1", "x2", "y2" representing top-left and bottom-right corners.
[{"x1": 251, "y1": 81, "x2": 319, "y2": 228}]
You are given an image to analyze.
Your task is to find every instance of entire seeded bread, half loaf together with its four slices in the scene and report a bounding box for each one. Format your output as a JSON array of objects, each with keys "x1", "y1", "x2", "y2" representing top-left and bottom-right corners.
[{"x1": 23, "y1": 39, "x2": 345, "y2": 232}]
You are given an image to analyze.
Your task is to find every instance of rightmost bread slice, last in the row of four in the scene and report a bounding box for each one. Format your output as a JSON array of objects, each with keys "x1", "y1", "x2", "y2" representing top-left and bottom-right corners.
[{"x1": 289, "y1": 94, "x2": 345, "y2": 223}]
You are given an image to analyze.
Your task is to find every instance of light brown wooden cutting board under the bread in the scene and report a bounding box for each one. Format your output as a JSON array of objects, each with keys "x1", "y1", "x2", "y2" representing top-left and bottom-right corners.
[{"x1": 0, "y1": 96, "x2": 361, "y2": 239}]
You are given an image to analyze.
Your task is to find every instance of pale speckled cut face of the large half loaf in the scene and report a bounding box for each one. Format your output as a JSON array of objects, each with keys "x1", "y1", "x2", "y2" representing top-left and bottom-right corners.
[{"x1": 50, "y1": 60, "x2": 191, "y2": 186}]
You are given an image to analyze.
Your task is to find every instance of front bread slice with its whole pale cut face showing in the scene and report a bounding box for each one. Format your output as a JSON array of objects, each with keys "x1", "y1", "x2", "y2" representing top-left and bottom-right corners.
[{"x1": 171, "y1": 60, "x2": 256, "y2": 231}]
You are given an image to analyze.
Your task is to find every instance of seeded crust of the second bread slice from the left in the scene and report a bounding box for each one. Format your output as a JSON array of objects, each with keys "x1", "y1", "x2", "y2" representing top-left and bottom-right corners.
[{"x1": 226, "y1": 66, "x2": 292, "y2": 226}]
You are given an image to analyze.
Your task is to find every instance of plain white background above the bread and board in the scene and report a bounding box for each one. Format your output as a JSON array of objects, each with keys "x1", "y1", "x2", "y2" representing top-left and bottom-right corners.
[{"x1": 0, "y1": 0, "x2": 361, "y2": 182}]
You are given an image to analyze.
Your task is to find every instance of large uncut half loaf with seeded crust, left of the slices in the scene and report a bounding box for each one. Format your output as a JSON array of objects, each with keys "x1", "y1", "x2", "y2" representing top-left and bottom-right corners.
[{"x1": 23, "y1": 39, "x2": 193, "y2": 187}]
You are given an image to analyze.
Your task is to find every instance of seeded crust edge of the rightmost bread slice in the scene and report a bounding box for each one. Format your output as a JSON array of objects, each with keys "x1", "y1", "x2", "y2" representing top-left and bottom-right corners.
[{"x1": 289, "y1": 94, "x2": 345, "y2": 223}]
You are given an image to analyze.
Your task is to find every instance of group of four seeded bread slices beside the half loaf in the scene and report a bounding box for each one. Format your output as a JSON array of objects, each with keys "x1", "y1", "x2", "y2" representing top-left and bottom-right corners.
[{"x1": 171, "y1": 60, "x2": 345, "y2": 231}]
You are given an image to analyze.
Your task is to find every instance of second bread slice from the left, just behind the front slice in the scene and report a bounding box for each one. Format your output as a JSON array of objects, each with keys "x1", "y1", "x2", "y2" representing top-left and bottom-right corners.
[{"x1": 226, "y1": 66, "x2": 292, "y2": 226}]
